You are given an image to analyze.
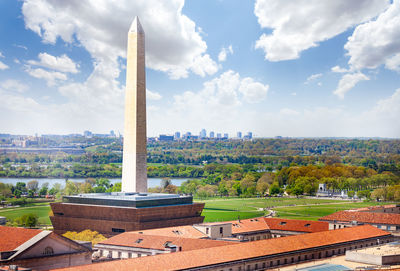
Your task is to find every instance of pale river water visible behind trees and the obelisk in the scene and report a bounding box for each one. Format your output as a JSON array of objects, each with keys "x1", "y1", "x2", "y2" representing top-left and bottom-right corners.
[{"x1": 0, "y1": 178, "x2": 188, "y2": 188}]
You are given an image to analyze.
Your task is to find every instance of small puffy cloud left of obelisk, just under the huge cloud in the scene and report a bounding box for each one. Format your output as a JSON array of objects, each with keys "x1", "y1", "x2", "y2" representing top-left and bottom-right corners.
[{"x1": 28, "y1": 53, "x2": 79, "y2": 73}]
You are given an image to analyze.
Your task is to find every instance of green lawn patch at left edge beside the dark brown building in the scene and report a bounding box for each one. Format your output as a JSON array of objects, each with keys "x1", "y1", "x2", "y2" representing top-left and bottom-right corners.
[{"x1": 0, "y1": 206, "x2": 51, "y2": 225}]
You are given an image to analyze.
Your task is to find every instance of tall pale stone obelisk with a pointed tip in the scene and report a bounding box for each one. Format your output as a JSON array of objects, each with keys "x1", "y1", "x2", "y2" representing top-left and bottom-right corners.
[{"x1": 122, "y1": 17, "x2": 147, "y2": 192}]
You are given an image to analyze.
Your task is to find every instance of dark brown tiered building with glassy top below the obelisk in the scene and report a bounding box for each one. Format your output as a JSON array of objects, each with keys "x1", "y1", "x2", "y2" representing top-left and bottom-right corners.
[{"x1": 50, "y1": 192, "x2": 204, "y2": 237}]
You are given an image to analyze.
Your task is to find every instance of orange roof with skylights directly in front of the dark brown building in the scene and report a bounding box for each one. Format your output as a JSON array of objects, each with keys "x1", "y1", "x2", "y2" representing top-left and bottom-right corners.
[{"x1": 99, "y1": 232, "x2": 232, "y2": 251}]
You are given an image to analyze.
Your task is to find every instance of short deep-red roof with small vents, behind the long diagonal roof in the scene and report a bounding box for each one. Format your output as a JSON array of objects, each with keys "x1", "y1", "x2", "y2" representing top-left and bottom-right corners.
[{"x1": 264, "y1": 217, "x2": 329, "y2": 232}]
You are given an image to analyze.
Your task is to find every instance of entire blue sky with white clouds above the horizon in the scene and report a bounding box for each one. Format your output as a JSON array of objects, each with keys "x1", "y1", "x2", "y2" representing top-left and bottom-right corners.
[{"x1": 0, "y1": 0, "x2": 400, "y2": 138}]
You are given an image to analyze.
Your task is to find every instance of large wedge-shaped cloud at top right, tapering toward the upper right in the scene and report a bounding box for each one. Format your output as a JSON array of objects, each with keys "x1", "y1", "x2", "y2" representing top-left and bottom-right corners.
[{"x1": 254, "y1": 0, "x2": 390, "y2": 61}]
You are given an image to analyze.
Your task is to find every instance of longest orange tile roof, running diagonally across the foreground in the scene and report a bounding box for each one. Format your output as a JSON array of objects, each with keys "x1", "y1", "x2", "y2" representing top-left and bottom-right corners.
[{"x1": 54, "y1": 225, "x2": 389, "y2": 271}]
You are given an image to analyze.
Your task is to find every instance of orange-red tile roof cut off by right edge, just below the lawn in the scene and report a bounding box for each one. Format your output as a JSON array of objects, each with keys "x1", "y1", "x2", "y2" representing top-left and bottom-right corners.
[{"x1": 319, "y1": 210, "x2": 400, "y2": 225}]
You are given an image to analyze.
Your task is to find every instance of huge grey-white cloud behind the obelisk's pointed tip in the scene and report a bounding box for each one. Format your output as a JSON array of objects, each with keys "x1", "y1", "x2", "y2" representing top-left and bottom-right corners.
[{"x1": 22, "y1": 0, "x2": 216, "y2": 78}]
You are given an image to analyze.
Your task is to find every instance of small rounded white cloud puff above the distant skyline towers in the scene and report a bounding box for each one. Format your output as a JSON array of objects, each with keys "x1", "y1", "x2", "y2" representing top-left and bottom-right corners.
[{"x1": 239, "y1": 77, "x2": 269, "y2": 103}]
